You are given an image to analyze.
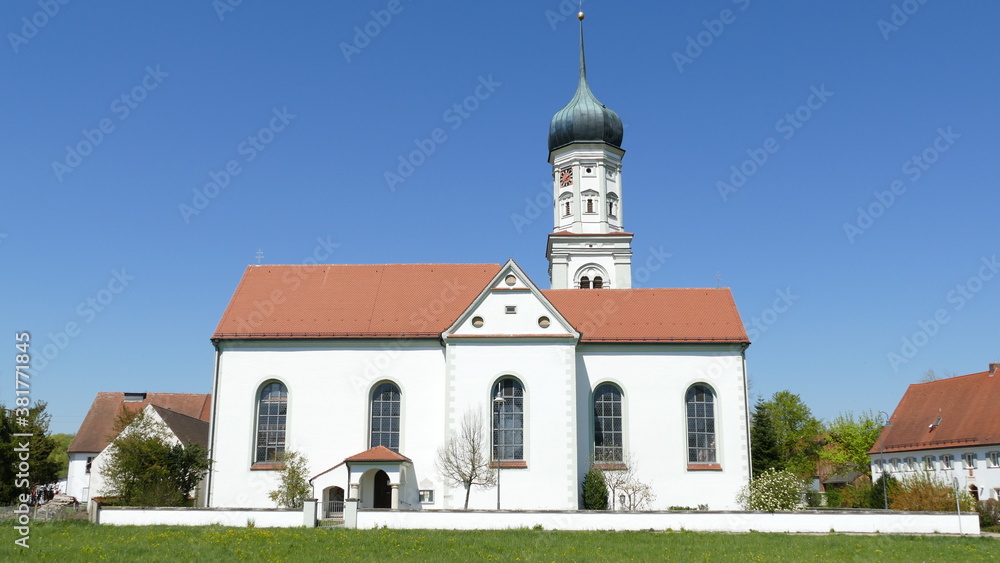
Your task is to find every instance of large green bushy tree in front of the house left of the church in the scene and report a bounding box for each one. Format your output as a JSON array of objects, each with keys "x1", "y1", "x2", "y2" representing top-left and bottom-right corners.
[{"x1": 101, "y1": 408, "x2": 211, "y2": 506}]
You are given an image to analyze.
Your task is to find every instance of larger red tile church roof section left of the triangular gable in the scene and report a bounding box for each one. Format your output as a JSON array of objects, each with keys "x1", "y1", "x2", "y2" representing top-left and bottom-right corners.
[{"x1": 212, "y1": 264, "x2": 500, "y2": 339}]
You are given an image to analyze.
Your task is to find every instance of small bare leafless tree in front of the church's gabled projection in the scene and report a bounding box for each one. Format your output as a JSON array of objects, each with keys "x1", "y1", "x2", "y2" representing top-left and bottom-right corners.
[{"x1": 436, "y1": 407, "x2": 497, "y2": 510}]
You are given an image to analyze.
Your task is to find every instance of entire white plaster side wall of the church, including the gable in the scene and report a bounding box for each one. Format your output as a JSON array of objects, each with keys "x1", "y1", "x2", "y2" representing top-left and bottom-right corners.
[{"x1": 209, "y1": 338, "x2": 749, "y2": 510}]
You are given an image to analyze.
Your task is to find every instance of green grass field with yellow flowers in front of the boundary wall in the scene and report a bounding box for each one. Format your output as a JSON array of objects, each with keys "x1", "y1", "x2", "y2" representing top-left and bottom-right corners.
[{"x1": 0, "y1": 521, "x2": 1000, "y2": 562}]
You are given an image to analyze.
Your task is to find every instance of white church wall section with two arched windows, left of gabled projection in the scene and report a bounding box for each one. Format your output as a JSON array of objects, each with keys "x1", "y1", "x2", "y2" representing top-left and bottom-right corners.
[{"x1": 209, "y1": 340, "x2": 444, "y2": 508}]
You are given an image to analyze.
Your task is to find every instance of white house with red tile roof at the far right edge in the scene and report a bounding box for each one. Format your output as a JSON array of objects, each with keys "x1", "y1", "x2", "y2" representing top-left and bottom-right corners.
[{"x1": 868, "y1": 364, "x2": 1000, "y2": 500}]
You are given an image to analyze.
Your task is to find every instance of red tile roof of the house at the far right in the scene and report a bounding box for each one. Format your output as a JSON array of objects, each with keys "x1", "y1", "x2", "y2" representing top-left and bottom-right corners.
[{"x1": 869, "y1": 371, "x2": 1000, "y2": 454}]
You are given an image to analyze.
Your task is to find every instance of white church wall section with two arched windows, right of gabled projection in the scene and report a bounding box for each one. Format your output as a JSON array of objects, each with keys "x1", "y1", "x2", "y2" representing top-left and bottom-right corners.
[{"x1": 577, "y1": 344, "x2": 750, "y2": 510}]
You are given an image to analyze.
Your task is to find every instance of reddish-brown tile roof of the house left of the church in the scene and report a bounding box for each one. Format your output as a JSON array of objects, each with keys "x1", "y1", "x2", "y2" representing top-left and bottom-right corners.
[{"x1": 68, "y1": 392, "x2": 212, "y2": 453}]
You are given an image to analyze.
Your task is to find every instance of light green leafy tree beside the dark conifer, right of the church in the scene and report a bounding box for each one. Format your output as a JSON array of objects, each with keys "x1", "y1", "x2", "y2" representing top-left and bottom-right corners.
[{"x1": 765, "y1": 391, "x2": 823, "y2": 478}]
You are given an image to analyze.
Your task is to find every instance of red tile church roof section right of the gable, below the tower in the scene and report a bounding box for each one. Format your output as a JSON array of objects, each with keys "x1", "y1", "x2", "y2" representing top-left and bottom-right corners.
[{"x1": 542, "y1": 288, "x2": 750, "y2": 343}]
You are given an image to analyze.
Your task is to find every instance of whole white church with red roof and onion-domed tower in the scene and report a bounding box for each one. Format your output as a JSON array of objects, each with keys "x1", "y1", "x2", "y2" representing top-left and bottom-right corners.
[{"x1": 208, "y1": 18, "x2": 750, "y2": 510}]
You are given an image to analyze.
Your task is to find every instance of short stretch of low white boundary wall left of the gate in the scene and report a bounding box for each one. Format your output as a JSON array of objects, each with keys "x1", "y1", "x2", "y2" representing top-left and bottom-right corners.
[{"x1": 97, "y1": 506, "x2": 306, "y2": 528}]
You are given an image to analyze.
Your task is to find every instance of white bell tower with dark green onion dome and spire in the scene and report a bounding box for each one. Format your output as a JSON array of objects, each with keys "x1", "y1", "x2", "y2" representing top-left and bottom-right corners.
[{"x1": 545, "y1": 12, "x2": 632, "y2": 289}]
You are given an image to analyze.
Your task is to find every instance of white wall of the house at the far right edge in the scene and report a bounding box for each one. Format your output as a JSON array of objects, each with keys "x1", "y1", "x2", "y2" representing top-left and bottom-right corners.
[{"x1": 869, "y1": 444, "x2": 1000, "y2": 500}]
